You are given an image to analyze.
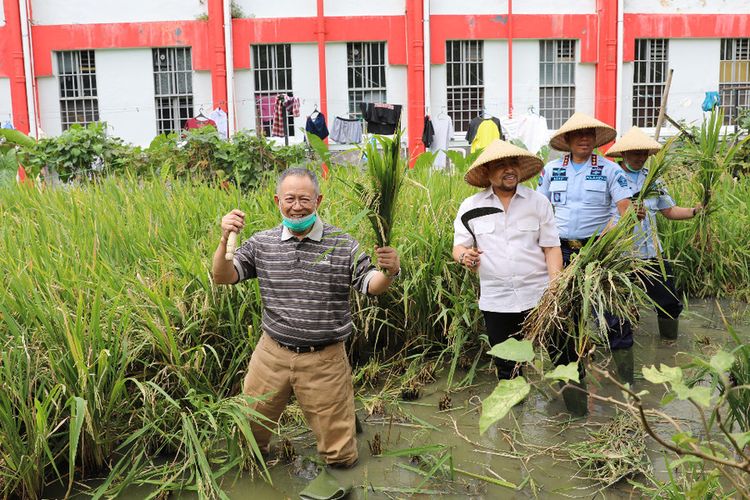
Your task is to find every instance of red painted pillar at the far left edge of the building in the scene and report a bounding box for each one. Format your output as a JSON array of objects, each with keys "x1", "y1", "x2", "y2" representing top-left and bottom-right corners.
[{"x1": 0, "y1": 0, "x2": 30, "y2": 134}]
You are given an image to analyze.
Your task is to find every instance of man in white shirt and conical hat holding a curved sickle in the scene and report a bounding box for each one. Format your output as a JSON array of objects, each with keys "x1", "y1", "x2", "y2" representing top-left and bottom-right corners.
[{"x1": 453, "y1": 140, "x2": 562, "y2": 379}]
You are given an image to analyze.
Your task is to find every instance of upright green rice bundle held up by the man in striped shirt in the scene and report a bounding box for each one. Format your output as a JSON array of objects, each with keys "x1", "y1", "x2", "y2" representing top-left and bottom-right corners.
[{"x1": 350, "y1": 128, "x2": 409, "y2": 247}]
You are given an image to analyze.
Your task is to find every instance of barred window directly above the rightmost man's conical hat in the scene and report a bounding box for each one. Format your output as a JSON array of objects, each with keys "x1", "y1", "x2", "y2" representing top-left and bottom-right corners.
[{"x1": 633, "y1": 39, "x2": 669, "y2": 127}]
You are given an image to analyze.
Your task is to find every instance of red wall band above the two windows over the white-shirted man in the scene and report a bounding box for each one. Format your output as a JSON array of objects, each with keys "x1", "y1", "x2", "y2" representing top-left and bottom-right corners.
[{"x1": 430, "y1": 14, "x2": 598, "y2": 64}]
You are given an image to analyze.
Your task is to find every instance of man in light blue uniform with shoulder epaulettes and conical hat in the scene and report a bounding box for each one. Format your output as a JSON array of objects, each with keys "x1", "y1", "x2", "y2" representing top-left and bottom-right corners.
[{"x1": 537, "y1": 113, "x2": 632, "y2": 416}]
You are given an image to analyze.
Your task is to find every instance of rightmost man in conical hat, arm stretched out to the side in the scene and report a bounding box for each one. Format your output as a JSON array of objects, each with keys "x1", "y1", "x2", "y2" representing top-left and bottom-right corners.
[{"x1": 607, "y1": 127, "x2": 703, "y2": 372}]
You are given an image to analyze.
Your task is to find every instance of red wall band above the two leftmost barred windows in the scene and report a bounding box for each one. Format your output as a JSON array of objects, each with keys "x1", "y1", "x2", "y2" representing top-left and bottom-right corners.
[{"x1": 32, "y1": 21, "x2": 212, "y2": 76}]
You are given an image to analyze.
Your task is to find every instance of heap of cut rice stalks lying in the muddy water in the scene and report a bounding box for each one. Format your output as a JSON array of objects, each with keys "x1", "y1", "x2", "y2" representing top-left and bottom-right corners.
[{"x1": 568, "y1": 412, "x2": 651, "y2": 487}]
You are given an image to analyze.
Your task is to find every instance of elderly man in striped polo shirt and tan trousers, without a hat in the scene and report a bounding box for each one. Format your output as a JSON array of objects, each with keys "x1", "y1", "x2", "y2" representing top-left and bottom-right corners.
[{"x1": 213, "y1": 168, "x2": 400, "y2": 467}]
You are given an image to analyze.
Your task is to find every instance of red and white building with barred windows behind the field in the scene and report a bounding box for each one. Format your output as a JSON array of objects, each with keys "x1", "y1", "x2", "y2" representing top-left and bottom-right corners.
[{"x1": 0, "y1": 0, "x2": 750, "y2": 151}]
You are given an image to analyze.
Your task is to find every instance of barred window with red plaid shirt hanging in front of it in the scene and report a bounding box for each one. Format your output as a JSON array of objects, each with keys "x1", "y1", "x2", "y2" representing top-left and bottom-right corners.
[{"x1": 253, "y1": 43, "x2": 294, "y2": 136}]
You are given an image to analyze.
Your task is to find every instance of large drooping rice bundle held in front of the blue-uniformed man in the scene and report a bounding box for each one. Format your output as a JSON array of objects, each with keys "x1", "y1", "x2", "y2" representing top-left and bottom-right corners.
[{"x1": 523, "y1": 210, "x2": 653, "y2": 355}]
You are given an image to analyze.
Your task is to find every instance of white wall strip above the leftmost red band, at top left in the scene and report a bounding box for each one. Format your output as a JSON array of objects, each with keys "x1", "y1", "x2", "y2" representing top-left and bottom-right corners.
[{"x1": 31, "y1": 0, "x2": 207, "y2": 25}]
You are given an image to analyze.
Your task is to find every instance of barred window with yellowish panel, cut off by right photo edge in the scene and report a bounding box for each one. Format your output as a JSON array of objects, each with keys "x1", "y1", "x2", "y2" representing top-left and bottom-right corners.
[{"x1": 719, "y1": 38, "x2": 750, "y2": 125}]
